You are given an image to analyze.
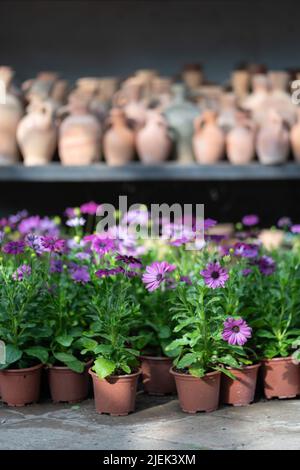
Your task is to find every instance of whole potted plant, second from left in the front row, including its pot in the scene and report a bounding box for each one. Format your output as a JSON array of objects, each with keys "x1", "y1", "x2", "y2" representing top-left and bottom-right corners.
[{"x1": 47, "y1": 242, "x2": 92, "y2": 403}]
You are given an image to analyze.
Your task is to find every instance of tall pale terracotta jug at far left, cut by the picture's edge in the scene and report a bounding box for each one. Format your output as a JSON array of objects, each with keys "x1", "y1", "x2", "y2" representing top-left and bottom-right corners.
[{"x1": 0, "y1": 67, "x2": 23, "y2": 165}]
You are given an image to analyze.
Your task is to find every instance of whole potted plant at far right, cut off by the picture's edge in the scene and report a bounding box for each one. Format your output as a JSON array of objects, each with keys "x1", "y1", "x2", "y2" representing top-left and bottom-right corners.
[{"x1": 252, "y1": 250, "x2": 300, "y2": 398}]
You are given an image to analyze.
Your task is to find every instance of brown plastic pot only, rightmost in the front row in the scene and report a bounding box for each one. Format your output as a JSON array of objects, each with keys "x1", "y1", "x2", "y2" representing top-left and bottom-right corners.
[{"x1": 262, "y1": 357, "x2": 300, "y2": 399}]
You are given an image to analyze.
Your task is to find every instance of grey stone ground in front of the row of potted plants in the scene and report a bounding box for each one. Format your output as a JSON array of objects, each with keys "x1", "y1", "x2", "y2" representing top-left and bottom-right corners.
[{"x1": 0, "y1": 392, "x2": 300, "y2": 450}]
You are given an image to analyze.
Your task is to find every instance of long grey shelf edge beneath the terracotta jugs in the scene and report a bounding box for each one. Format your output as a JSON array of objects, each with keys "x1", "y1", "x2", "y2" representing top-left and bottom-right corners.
[{"x1": 0, "y1": 163, "x2": 300, "y2": 183}]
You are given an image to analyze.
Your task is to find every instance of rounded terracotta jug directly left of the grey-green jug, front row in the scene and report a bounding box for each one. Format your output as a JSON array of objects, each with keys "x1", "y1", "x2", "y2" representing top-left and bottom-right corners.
[{"x1": 136, "y1": 109, "x2": 172, "y2": 164}]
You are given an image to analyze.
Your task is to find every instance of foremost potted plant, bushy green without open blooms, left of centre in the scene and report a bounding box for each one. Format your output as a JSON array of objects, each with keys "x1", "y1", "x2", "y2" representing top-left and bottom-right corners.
[{"x1": 87, "y1": 267, "x2": 141, "y2": 416}]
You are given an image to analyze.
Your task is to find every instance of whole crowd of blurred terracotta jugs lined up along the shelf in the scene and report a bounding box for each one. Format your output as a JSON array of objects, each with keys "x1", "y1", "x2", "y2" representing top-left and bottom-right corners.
[{"x1": 0, "y1": 64, "x2": 300, "y2": 167}]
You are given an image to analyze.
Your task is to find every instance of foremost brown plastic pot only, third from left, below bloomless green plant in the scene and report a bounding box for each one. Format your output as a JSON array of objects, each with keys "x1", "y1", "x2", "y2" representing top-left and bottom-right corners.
[{"x1": 89, "y1": 369, "x2": 141, "y2": 416}]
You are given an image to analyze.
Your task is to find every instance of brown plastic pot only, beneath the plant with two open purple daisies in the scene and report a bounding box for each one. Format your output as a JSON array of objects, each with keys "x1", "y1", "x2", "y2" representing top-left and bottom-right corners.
[{"x1": 170, "y1": 368, "x2": 221, "y2": 413}]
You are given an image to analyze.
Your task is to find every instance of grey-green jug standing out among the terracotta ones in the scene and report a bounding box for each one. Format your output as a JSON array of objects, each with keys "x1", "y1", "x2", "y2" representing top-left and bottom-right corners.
[{"x1": 164, "y1": 84, "x2": 199, "y2": 164}]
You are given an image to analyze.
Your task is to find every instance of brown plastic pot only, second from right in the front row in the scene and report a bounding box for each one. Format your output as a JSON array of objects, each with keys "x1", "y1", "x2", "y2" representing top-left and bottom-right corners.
[{"x1": 221, "y1": 364, "x2": 260, "y2": 406}]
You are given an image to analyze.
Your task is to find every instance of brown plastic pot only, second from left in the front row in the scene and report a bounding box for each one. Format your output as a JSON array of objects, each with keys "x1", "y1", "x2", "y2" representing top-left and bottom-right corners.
[{"x1": 48, "y1": 361, "x2": 93, "y2": 403}]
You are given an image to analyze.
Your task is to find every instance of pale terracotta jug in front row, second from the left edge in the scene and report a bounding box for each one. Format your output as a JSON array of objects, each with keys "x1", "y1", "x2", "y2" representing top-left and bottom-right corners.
[{"x1": 17, "y1": 101, "x2": 57, "y2": 166}]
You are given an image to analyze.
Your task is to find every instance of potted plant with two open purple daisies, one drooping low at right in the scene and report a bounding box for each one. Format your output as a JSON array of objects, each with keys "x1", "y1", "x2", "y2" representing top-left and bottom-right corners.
[{"x1": 167, "y1": 254, "x2": 251, "y2": 413}]
